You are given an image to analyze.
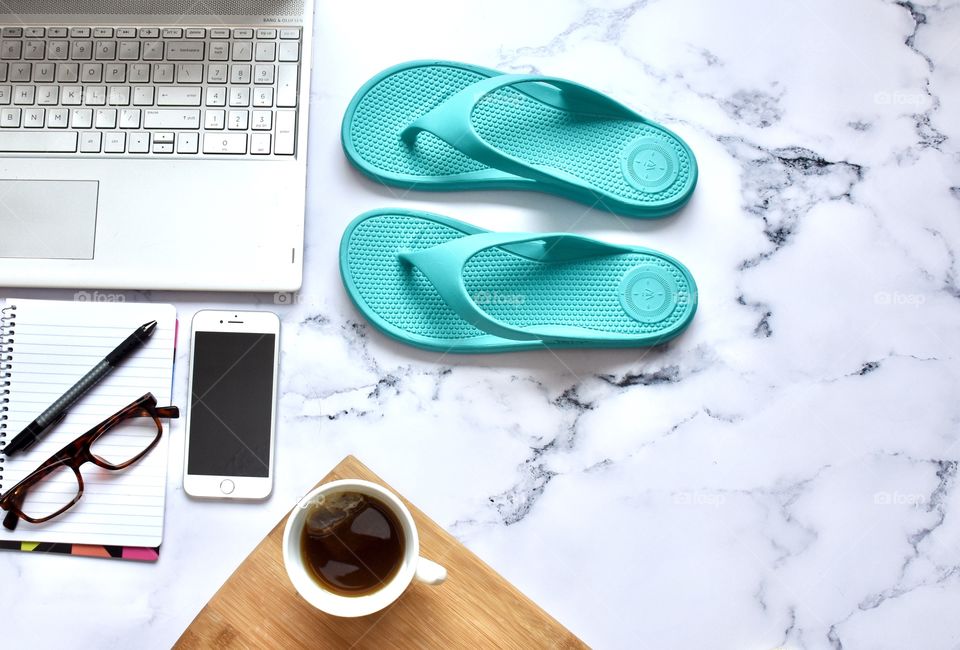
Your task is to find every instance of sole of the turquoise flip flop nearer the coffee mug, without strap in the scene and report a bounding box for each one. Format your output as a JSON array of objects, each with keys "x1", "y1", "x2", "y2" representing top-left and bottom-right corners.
[{"x1": 340, "y1": 209, "x2": 697, "y2": 353}]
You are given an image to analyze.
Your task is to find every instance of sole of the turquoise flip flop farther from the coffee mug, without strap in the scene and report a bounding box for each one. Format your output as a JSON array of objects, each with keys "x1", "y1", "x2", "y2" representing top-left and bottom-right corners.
[{"x1": 341, "y1": 61, "x2": 697, "y2": 217}]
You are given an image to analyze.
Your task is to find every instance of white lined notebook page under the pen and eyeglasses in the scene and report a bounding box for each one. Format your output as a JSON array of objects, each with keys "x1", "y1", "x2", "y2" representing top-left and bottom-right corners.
[{"x1": 0, "y1": 300, "x2": 176, "y2": 547}]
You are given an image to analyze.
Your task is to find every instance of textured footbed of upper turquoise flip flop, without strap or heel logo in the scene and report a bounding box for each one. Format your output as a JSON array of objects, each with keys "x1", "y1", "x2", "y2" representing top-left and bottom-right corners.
[{"x1": 349, "y1": 64, "x2": 694, "y2": 206}]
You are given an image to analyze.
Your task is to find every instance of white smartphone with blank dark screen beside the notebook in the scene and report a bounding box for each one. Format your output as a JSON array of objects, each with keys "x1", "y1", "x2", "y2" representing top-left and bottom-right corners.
[{"x1": 183, "y1": 310, "x2": 280, "y2": 499}]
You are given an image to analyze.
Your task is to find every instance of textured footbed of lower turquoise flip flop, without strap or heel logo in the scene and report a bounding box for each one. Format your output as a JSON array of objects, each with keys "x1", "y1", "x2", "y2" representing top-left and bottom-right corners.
[{"x1": 343, "y1": 214, "x2": 694, "y2": 344}]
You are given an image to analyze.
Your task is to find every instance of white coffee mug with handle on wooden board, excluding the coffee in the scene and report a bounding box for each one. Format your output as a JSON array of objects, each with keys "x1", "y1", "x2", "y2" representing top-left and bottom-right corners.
[{"x1": 283, "y1": 479, "x2": 447, "y2": 617}]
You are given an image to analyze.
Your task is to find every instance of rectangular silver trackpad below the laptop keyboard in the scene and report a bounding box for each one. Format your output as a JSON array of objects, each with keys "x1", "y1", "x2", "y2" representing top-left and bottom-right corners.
[{"x1": 0, "y1": 179, "x2": 99, "y2": 260}]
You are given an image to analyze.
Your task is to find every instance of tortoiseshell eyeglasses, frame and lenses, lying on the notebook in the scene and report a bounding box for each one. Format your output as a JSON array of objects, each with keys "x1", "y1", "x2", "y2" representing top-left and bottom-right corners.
[{"x1": 0, "y1": 393, "x2": 180, "y2": 530}]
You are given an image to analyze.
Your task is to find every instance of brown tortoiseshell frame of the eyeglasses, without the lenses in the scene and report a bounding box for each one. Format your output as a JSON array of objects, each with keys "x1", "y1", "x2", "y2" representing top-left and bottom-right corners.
[{"x1": 0, "y1": 393, "x2": 180, "y2": 530}]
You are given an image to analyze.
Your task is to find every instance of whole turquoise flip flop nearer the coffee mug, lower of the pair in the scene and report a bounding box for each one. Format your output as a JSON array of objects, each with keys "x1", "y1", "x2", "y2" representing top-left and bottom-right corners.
[{"x1": 340, "y1": 208, "x2": 697, "y2": 353}]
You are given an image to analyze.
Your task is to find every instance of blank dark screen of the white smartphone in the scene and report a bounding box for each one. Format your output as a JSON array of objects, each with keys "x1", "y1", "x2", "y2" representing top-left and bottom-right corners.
[{"x1": 187, "y1": 332, "x2": 275, "y2": 477}]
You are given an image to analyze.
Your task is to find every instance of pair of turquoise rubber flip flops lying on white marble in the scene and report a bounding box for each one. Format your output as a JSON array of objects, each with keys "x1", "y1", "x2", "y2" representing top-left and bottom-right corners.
[{"x1": 340, "y1": 61, "x2": 697, "y2": 353}]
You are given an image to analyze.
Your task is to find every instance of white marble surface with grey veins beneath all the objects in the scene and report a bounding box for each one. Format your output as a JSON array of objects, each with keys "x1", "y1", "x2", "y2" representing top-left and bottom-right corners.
[{"x1": 0, "y1": 0, "x2": 960, "y2": 649}]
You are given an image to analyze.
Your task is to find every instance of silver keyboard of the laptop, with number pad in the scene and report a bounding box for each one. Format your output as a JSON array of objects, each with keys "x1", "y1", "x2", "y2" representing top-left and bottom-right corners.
[{"x1": 0, "y1": 27, "x2": 302, "y2": 158}]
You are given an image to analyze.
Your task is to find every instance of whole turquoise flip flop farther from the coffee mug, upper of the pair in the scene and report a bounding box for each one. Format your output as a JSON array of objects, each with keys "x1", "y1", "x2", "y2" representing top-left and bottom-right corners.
[{"x1": 341, "y1": 61, "x2": 697, "y2": 218}]
